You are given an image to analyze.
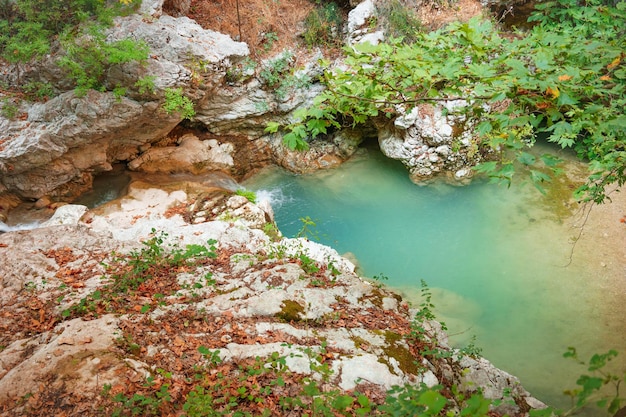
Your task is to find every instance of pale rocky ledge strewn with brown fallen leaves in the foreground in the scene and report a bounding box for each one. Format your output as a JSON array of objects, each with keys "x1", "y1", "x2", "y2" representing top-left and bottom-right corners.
[{"x1": 0, "y1": 183, "x2": 541, "y2": 416}]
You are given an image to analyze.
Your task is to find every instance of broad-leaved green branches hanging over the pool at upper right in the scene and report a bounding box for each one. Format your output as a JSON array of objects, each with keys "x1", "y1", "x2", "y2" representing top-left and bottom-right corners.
[{"x1": 267, "y1": 0, "x2": 626, "y2": 203}]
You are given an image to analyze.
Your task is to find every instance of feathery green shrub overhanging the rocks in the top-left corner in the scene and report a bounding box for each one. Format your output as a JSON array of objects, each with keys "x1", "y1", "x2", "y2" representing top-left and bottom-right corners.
[{"x1": 0, "y1": 0, "x2": 148, "y2": 99}]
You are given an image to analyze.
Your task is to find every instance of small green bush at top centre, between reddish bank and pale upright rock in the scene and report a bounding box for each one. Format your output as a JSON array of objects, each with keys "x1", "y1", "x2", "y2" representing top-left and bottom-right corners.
[{"x1": 302, "y1": 2, "x2": 343, "y2": 47}]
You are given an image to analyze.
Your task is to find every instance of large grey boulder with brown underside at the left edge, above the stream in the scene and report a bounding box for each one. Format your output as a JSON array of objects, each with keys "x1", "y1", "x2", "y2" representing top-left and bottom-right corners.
[{"x1": 0, "y1": 90, "x2": 178, "y2": 198}]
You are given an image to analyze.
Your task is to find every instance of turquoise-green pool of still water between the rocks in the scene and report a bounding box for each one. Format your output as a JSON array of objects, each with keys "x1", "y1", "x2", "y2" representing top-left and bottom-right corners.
[{"x1": 245, "y1": 144, "x2": 624, "y2": 407}]
